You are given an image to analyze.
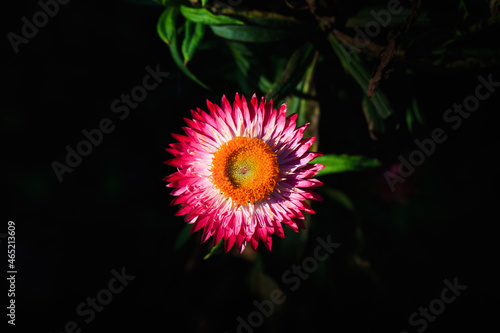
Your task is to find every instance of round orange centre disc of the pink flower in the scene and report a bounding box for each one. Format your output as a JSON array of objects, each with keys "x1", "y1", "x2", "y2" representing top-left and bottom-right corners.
[{"x1": 211, "y1": 136, "x2": 279, "y2": 205}]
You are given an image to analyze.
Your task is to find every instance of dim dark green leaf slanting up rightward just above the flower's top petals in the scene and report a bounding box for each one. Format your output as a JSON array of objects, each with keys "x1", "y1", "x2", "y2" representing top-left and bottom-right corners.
[{"x1": 266, "y1": 42, "x2": 314, "y2": 101}]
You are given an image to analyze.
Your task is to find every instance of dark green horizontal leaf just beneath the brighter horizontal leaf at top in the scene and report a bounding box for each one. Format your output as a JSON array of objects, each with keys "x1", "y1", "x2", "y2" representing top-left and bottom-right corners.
[{"x1": 210, "y1": 25, "x2": 288, "y2": 43}]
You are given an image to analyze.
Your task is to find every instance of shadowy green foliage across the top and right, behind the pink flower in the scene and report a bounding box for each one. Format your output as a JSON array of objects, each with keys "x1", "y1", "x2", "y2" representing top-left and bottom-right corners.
[{"x1": 161, "y1": 0, "x2": 499, "y2": 256}]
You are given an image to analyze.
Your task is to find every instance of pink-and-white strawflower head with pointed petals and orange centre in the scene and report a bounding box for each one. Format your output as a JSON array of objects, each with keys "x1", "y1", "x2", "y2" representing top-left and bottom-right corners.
[{"x1": 164, "y1": 94, "x2": 324, "y2": 252}]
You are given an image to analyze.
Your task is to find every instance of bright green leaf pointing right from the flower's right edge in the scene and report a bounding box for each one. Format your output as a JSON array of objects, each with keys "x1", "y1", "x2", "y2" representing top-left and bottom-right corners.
[{"x1": 311, "y1": 154, "x2": 380, "y2": 176}]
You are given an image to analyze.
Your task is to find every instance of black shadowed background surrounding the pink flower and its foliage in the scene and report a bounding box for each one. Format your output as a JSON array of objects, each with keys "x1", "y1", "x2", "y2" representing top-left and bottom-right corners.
[{"x1": 0, "y1": 0, "x2": 500, "y2": 332}]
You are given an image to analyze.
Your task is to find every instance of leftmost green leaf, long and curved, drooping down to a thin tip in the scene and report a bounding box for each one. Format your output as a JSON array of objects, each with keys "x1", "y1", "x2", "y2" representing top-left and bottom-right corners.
[{"x1": 157, "y1": 7, "x2": 210, "y2": 89}]
